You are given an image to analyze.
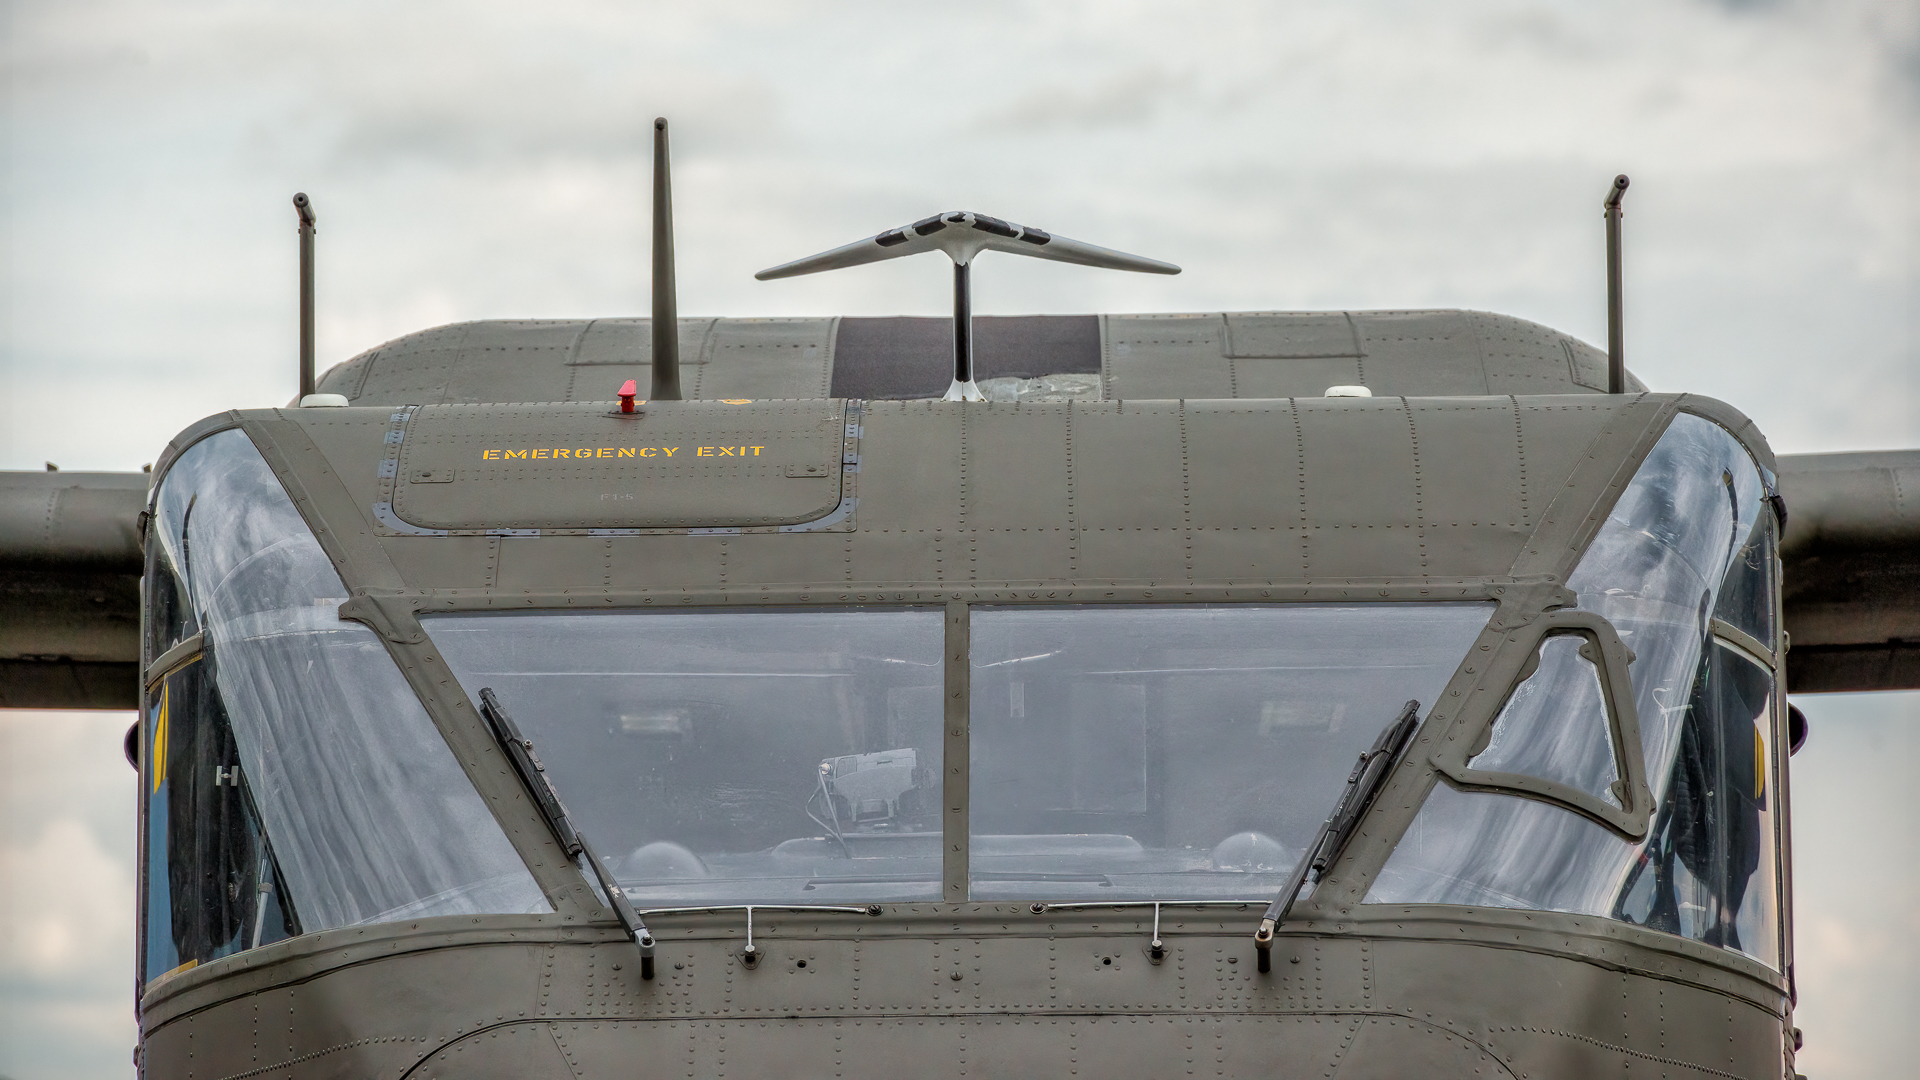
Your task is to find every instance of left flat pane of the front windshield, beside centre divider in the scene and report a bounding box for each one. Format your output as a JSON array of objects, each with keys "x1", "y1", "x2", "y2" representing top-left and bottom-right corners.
[{"x1": 424, "y1": 607, "x2": 945, "y2": 909}]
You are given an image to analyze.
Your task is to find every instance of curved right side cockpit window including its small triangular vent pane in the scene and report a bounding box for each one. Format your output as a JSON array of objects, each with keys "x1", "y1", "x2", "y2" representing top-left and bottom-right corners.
[{"x1": 1367, "y1": 415, "x2": 1780, "y2": 967}]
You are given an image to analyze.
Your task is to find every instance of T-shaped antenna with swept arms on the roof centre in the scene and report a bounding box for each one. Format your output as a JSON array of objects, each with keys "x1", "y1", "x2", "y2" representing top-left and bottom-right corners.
[{"x1": 756, "y1": 209, "x2": 1181, "y2": 402}]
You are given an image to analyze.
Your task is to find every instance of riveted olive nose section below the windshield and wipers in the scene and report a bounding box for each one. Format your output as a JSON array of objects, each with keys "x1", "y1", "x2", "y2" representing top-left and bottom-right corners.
[{"x1": 146, "y1": 905, "x2": 1786, "y2": 1076}]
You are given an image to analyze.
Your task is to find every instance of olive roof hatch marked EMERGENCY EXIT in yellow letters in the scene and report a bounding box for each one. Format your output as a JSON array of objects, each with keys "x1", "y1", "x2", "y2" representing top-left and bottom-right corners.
[{"x1": 376, "y1": 400, "x2": 856, "y2": 532}]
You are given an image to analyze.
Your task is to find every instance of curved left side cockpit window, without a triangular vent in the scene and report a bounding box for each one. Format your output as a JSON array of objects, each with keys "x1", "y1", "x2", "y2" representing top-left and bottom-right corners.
[{"x1": 140, "y1": 430, "x2": 549, "y2": 978}]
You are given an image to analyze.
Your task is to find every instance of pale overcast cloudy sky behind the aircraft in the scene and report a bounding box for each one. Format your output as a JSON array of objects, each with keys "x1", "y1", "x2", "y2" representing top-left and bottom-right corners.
[{"x1": 0, "y1": 0, "x2": 1920, "y2": 1080}]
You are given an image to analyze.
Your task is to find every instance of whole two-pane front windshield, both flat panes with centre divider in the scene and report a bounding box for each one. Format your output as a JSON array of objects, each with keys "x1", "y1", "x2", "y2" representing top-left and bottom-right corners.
[{"x1": 424, "y1": 603, "x2": 1492, "y2": 909}]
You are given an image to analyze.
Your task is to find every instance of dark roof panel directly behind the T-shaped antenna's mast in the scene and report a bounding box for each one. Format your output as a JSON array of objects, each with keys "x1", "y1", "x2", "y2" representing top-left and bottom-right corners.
[{"x1": 831, "y1": 315, "x2": 1100, "y2": 402}]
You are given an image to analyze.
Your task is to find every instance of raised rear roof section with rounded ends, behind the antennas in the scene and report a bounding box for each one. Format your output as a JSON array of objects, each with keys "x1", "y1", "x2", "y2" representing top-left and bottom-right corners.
[{"x1": 319, "y1": 311, "x2": 1644, "y2": 405}]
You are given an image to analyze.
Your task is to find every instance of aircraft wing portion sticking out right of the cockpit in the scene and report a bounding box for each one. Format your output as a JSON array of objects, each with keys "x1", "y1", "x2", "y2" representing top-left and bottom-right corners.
[{"x1": 1780, "y1": 450, "x2": 1920, "y2": 694}]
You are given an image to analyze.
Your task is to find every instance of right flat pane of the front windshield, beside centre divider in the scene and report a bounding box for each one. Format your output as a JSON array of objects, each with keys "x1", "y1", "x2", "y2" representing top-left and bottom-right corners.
[{"x1": 970, "y1": 603, "x2": 1492, "y2": 903}]
